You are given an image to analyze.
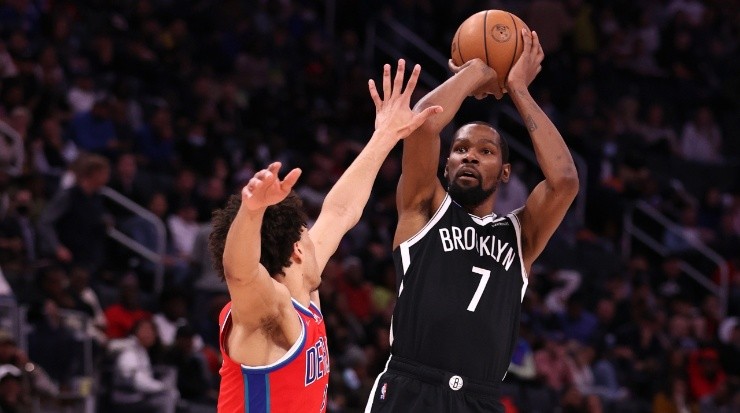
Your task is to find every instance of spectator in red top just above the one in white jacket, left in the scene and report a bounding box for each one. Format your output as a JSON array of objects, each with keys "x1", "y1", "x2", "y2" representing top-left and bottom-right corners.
[{"x1": 105, "y1": 273, "x2": 152, "y2": 339}]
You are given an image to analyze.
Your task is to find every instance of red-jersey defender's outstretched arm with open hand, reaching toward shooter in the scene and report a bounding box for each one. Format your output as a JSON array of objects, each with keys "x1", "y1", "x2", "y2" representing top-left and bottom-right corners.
[{"x1": 310, "y1": 59, "x2": 442, "y2": 284}]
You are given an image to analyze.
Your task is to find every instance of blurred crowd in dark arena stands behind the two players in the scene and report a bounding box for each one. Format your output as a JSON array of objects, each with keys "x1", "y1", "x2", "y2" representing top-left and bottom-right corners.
[{"x1": 0, "y1": 0, "x2": 740, "y2": 413}]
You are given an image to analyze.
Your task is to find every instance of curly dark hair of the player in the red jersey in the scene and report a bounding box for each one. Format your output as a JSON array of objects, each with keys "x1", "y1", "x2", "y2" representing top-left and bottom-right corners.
[{"x1": 208, "y1": 191, "x2": 308, "y2": 280}]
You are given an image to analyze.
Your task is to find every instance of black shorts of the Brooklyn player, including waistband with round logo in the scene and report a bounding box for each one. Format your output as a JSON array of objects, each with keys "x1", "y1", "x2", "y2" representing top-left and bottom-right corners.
[{"x1": 365, "y1": 356, "x2": 504, "y2": 413}]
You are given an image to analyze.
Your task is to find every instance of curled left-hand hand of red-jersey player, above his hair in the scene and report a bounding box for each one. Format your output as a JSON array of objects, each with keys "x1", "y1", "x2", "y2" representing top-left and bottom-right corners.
[{"x1": 242, "y1": 162, "x2": 301, "y2": 211}]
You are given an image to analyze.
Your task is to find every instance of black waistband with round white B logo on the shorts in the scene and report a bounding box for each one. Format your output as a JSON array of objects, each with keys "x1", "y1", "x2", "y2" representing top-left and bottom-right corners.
[{"x1": 388, "y1": 356, "x2": 501, "y2": 397}]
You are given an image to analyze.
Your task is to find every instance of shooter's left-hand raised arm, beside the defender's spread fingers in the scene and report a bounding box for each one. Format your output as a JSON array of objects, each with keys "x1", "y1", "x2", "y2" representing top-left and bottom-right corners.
[{"x1": 393, "y1": 59, "x2": 496, "y2": 248}]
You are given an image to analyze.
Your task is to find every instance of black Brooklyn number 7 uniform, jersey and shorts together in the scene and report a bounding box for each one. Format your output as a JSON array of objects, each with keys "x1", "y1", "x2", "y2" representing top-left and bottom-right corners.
[{"x1": 366, "y1": 195, "x2": 527, "y2": 412}]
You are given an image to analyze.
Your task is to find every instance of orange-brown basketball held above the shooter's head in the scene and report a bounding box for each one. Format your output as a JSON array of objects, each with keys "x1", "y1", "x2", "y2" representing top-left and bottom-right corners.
[{"x1": 451, "y1": 10, "x2": 529, "y2": 88}]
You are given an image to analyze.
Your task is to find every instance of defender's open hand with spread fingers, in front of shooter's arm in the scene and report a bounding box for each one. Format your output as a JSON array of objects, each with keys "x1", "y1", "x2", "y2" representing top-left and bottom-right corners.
[{"x1": 368, "y1": 59, "x2": 442, "y2": 139}]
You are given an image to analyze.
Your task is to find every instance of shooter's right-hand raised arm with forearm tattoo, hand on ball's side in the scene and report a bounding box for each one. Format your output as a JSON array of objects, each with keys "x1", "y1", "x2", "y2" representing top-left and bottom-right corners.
[{"x1": 507, "y1": 29, "x2": 578, "y2": 270}]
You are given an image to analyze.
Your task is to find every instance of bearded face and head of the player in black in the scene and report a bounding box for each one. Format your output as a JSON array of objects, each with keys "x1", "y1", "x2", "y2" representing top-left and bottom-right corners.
[{"x1": 445, "y1": 125, "x2": 509, "y2": 206}]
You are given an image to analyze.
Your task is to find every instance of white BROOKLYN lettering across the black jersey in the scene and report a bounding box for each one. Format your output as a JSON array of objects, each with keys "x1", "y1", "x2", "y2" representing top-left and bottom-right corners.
[{"x1": 439, "y1": 226, "x2": 517, "y2": 271}]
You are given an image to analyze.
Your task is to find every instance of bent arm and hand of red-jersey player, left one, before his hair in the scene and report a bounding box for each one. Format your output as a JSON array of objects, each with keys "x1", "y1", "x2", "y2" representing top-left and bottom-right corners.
[{"x1": 223, "y1": 162, "x2": 301, "y2": 328}]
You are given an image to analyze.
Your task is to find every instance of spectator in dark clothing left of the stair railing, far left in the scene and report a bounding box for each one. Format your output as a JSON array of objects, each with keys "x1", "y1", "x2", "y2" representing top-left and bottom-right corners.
[{"x1": 38, "y1": 155, "x2": 110, "y2": 273}]
